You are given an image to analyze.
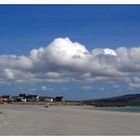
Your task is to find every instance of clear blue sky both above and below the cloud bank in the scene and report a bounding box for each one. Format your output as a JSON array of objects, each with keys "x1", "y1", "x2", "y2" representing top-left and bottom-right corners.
[{"x1": 0, "y1": 5, "x2": 140, "y2": 99}]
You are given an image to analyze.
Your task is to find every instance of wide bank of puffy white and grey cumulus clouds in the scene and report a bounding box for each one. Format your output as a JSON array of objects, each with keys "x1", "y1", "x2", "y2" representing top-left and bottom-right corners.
[{"x1": 0, "y1": 38, "x2": 140, "y2": 87}]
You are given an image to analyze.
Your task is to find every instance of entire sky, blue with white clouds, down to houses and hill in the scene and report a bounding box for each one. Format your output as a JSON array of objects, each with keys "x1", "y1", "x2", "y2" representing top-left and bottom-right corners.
[{"x1": 0, "y1": 5, "x2": 140, "y2": 100}]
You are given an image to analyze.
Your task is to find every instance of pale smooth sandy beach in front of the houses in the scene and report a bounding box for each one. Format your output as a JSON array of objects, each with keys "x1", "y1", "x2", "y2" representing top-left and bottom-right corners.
[{"x1": 0, "y1": 105, "x2": 140, "y2": 136}]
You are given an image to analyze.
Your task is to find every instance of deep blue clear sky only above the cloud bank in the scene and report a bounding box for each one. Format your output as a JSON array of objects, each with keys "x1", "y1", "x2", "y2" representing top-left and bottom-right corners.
[{"x1": 0, "y1": 5, "x2": 140, "y2": 54}]
